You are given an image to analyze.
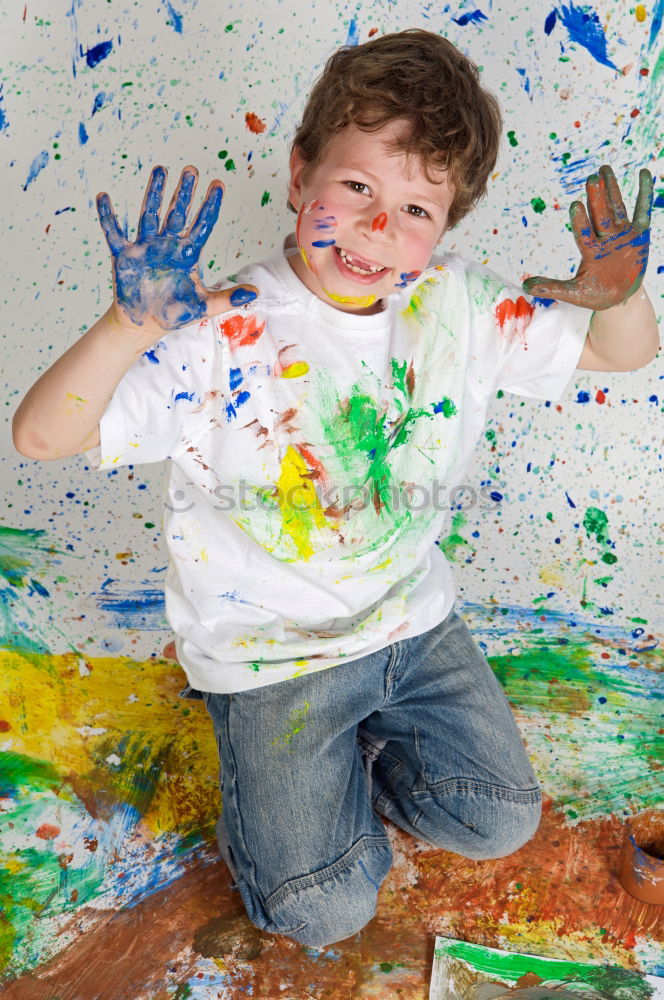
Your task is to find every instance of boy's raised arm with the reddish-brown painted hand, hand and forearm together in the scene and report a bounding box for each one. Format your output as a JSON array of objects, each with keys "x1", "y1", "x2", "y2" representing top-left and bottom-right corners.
[{"x1": 523, "y1": 166, "x2": 659, "y2": 371}]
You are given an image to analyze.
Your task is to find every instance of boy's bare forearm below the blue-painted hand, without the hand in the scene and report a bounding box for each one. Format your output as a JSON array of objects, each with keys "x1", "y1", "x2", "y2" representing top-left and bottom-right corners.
[{"x1": 12, "y1": 309, "x2": 158, "y2": 461}]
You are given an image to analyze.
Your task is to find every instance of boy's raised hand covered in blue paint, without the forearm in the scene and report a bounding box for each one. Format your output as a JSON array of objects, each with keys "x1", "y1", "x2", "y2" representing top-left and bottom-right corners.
[{"x1": 97, "y1": 166, "x2": 257, "y2": 336}]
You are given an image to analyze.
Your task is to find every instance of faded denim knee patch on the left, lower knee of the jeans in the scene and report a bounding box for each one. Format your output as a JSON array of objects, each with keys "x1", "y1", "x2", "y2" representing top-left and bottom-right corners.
[{"x1": 252, "y1": 836, "x2": 392, "y2": 947}]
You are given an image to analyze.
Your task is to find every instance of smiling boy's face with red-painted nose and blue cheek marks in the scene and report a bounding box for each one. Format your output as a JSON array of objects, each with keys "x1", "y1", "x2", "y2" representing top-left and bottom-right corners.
[{"x1": 289, "y1": 121, "x2": 454, "y2": 313}]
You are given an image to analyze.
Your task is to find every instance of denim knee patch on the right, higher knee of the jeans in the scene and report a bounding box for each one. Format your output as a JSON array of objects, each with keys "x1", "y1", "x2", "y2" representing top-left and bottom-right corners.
[{"x1": 413, "y1": 780, "x2": 542, "y2": 861}]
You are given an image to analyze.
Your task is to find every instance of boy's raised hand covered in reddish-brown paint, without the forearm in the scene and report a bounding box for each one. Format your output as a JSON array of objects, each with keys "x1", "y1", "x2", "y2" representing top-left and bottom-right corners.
[{"x1": 523, "y1": 166, "x2": 653, "y2": 310}]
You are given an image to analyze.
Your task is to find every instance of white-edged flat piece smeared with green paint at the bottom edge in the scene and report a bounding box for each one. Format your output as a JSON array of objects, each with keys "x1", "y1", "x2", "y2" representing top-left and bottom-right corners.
[{"x1": 429, "y1": 937, "x2": 664, "y2": 1000}]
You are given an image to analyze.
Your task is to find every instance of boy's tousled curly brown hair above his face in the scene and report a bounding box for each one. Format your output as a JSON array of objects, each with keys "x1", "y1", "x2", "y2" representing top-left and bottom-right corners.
[{"x1": 293, "y1": 28, "x2": 502, "y2": 228}]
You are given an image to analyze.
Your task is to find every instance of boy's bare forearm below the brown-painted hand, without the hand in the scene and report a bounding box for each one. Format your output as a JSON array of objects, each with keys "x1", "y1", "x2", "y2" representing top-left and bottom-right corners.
[{"x1": 579, "y1": 288, "x2": 659, "y2": 372}]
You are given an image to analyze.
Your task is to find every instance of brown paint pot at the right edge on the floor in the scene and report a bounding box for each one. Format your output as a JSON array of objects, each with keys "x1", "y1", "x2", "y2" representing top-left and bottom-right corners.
[{"x1": 620, "y1": 809, "x2": 664, "y2": 903}]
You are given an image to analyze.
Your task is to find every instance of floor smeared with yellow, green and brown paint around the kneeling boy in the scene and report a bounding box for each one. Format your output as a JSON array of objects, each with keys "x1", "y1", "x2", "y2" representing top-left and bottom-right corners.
[{"x1": 0, "y1": 605, "x2": 664, "y2": 1000}]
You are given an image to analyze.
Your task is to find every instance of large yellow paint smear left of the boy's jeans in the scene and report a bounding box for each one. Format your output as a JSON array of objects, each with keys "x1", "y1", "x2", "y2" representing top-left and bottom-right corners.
[{"x1": 0, "y1": 650, "x2": 219, "y2": 834}]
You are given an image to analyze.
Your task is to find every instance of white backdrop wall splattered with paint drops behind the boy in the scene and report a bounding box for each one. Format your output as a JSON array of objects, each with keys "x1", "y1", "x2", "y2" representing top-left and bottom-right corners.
[{"x1": 0, "y1": 0, "x2": 664, "y2": 658}]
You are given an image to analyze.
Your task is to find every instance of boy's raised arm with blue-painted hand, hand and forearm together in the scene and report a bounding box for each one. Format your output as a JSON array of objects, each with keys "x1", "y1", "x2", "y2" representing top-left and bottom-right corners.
[{"x1": 12, "y1": 167, "x2": 256, "y2": 461}]
